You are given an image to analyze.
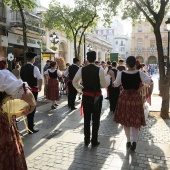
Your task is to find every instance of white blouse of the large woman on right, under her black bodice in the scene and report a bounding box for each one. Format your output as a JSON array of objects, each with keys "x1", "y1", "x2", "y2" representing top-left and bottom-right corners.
[{"x1": 113, "y1": 70, "x2": 153, "y2": 87}]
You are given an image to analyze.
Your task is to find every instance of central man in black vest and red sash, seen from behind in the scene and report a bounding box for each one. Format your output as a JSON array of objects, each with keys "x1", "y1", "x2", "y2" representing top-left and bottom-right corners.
[{"x1": 73, "y1": 51, "x2": 110, "y2": 147}]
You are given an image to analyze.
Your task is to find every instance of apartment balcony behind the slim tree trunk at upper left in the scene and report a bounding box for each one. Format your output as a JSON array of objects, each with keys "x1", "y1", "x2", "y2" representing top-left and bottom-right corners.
[{"x1": 10, "y1": 11, "x2": 45, "y2": 35}]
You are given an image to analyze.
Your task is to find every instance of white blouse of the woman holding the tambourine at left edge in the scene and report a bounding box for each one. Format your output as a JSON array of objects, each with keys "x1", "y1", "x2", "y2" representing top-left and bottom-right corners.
[{"x1": 0, "y1": 70, "x2": 28, "y2": 98}]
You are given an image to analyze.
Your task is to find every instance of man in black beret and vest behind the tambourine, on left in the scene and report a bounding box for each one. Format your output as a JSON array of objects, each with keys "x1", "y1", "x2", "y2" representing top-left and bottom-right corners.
[{"x1": 20, "y1": 52, "x2": 43, "y2": 134}]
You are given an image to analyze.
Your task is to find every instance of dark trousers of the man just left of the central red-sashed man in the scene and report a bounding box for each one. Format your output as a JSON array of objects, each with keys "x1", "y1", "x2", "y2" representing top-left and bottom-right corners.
[{"x1": 67, "y1": 82, "x2": 77, "y2": 109}]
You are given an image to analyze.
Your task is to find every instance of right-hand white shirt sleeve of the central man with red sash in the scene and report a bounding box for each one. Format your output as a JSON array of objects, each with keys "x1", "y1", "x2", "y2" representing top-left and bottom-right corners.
[{"x1": 99, "y1": 68, "x2": 110, "y2": 88}]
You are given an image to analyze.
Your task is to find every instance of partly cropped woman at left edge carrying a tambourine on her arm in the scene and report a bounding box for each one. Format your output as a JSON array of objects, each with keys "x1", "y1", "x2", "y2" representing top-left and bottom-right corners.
[{"x1": 0, "y1": 63, "x2": 36, "y2": 170}]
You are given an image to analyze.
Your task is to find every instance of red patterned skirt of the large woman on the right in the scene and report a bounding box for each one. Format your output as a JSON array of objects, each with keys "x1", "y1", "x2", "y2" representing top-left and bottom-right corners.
[{"x1": 114, "y1": 90, "x2": 146, "y2": 128}]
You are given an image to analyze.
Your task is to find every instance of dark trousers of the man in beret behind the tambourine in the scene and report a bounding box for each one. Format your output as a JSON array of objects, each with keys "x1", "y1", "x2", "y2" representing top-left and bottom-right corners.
[{"x1": 27, "y1": 92, "x2": 38, "y2": 130}]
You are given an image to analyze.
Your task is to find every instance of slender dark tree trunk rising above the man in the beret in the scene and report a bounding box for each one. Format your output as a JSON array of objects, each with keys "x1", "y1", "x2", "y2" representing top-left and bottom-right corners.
[{"x1": 16, "y1": 0, "x2": 28, "y2": 62}]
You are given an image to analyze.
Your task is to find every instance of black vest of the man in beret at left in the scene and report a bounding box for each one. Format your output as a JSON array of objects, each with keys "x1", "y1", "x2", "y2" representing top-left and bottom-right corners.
[{"x1": 20, "y1": 64, "x2": 37, "y2": 87}]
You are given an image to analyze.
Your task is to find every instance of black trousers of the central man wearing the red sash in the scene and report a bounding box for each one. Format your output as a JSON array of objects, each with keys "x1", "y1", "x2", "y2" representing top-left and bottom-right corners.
[{"x1": 82, "y1": 95, "x2": 103, "y2": 143}]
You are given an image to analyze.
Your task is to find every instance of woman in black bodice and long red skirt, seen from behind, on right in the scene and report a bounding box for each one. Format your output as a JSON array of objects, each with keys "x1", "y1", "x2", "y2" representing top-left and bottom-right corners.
[{"x1": 113, "y1": 56, "x2": 153, "y2": 151}]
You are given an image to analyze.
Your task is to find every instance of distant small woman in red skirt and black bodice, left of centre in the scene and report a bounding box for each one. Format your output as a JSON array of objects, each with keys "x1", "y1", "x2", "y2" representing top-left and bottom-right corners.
[{"x1": 44, "y1": 62, "x2": 62, "y2": 109}]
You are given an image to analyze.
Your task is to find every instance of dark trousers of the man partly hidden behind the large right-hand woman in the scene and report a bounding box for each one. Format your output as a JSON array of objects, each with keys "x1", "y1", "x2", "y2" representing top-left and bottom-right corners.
[{"x1": 108, "y1": 87, "x2": 120, "y2": 113}]
